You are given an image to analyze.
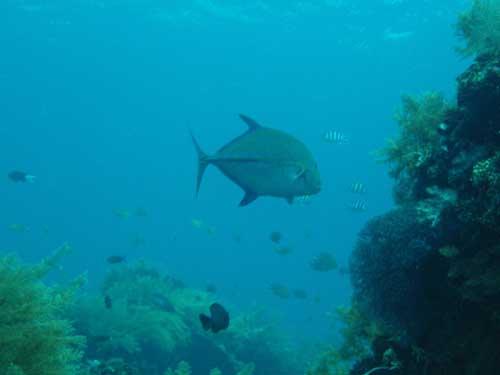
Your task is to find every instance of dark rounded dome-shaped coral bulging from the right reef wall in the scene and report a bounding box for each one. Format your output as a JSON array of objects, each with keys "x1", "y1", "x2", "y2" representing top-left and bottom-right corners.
[{"x1": 350, "y1": 206, "x2": 442, "y2": 340}]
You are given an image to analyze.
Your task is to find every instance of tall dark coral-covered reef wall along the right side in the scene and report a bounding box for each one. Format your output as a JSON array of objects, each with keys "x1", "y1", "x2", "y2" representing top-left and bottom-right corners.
[{"x1": 344, "y1": 13, "x2": 500, "y2": 375}]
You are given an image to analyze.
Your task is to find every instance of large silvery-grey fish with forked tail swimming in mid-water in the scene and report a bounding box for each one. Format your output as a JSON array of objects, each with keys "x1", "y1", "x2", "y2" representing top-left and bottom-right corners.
[{"x1": 191, "y1": 115, "x2": 321, "y2": 206}]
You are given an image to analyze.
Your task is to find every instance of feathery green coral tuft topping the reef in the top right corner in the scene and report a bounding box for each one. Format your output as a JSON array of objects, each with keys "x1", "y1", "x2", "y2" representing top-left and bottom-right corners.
[{"x1": 457, "y1": 0, "x2": 500, "y2": 56}]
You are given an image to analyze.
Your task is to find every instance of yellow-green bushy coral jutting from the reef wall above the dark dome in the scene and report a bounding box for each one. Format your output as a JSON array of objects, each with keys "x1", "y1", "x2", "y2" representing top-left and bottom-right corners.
[{"x1": 379, "y1": 92, "x2": 451, "y2": 177}]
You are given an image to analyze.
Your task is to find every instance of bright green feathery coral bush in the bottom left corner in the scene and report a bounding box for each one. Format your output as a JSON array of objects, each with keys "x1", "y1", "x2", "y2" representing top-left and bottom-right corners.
[{"x1": 0, "y1": 245, "x2": 84, "y2": 375}]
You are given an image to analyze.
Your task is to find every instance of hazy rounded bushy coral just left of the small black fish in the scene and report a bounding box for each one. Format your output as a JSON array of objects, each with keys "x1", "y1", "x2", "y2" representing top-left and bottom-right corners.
[{"x1": 72, "y1": 262, "x2": 192, "y2": 368}]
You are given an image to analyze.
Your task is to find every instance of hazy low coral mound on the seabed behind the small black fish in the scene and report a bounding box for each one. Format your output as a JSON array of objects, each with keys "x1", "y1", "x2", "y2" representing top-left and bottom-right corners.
[{"x1": 71, "y1": 262, "x2": 296, "y2": 375}]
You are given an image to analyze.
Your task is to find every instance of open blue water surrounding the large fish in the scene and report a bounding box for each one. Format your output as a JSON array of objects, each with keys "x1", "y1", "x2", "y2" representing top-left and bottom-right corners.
[{"x1": 0, "y1": 0, "x2": 467, "y2": 346}]
